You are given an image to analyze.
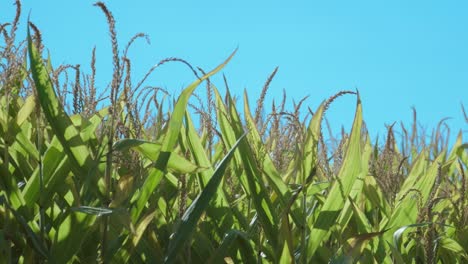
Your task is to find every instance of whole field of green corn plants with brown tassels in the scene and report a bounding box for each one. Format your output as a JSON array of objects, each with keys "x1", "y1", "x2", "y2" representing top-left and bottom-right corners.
[{"x1": 0, "y1": 0, "x2": 468, "y2": 263}]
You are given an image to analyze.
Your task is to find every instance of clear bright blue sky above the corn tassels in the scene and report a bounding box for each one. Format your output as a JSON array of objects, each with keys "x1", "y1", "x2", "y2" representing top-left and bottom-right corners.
[{"x1": 0, "y1": 0, "x2": 468, "y2": 144}]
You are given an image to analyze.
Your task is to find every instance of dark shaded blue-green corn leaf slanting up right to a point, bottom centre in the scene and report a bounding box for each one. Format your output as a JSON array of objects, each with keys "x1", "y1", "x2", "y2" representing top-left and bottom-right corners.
[{"x1": 164, "y1": 134, "x2": 246, "y2": 263}]
